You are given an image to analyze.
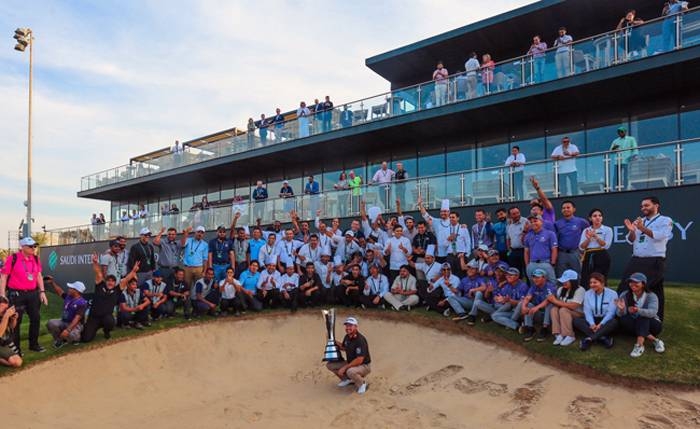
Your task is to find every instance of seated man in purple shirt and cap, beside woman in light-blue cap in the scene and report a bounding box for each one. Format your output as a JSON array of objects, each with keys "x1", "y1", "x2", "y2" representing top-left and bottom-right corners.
[{"x1": 520, "y1": 268, "x2": 557, "y2": 342}]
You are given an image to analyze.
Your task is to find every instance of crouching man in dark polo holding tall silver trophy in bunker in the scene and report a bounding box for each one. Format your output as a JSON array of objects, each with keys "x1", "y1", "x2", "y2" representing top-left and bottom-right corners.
[{"x1": 322, "y1": 309, "x2": 372, "y2": 395}]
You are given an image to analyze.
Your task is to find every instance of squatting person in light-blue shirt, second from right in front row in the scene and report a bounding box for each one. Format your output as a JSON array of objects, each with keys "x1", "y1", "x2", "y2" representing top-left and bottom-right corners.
[{"x1": 574, "y1": 273, "x2": 617, "y2": 351}]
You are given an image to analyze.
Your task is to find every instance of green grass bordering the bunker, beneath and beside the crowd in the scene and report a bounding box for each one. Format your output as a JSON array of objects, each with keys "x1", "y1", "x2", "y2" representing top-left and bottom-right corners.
[{"x1": 0, "y1": 285, "x2": 700, "y2": 387}]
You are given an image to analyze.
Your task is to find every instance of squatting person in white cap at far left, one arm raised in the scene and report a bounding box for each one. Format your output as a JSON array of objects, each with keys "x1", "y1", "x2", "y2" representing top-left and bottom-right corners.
[{"x1": 46, "y1": 277, "x2": 88, "y2": 349}]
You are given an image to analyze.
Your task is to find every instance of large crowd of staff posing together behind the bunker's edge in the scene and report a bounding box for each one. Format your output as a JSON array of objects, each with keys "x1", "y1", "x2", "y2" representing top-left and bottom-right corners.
[{"x1": 0, "y1": 172, "x2": 673, "y2": 366}]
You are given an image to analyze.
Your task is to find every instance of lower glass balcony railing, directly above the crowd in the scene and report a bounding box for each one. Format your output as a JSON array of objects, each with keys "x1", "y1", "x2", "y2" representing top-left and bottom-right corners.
[{"x1": 47, "y1": 139, "x2": 700, "y2": 245}]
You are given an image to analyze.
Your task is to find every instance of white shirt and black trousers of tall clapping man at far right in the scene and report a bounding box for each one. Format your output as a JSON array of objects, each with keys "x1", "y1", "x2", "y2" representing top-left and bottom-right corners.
[{"x1": 617, "y1": 214, "x2": 673, "y2": 321}]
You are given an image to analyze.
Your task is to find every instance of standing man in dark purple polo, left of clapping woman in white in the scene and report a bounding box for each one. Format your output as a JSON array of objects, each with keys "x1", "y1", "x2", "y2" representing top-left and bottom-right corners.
[{"x1": 554, "y1": 200, "x2": 590, "y2": 277}]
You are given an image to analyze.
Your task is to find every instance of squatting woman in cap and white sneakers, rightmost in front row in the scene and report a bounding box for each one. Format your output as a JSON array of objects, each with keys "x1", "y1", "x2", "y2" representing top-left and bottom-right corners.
[{"x1": 617, "y1": 273, "x2": 666, "y2": 357}]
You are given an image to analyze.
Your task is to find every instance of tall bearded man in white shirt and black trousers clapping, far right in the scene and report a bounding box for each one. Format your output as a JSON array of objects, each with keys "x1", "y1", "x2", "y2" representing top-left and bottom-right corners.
[{"x1": 617, "y1": 196, "x2": 673, "y2": 321}]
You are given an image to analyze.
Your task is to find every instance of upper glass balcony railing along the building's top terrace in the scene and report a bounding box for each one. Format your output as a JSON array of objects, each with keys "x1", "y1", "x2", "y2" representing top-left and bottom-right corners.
[{"x1": 80, "y1": 8, "x2": 700, "y2": 191}]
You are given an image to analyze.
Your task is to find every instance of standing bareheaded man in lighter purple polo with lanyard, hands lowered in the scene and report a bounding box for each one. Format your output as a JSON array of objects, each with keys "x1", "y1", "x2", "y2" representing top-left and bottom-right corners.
[{"x1": 523, "y1": 215, "x2": 559, "y2": 281}]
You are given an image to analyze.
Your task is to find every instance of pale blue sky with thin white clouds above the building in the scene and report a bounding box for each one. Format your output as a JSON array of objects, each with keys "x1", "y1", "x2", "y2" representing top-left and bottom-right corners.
[{"x1": 0, "y1": 0, "x2": 530, "y2": 247}]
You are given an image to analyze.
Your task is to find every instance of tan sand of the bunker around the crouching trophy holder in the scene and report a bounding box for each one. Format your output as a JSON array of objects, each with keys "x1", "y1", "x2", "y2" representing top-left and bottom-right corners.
[{"x1": 0, "y1": 314, "x2": 700, "y2": 429}]
